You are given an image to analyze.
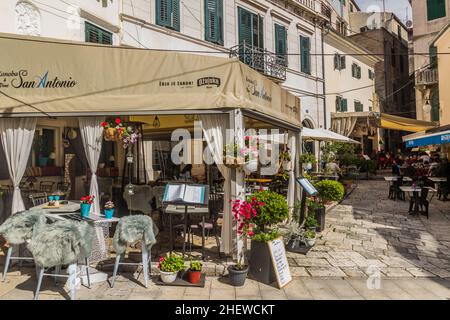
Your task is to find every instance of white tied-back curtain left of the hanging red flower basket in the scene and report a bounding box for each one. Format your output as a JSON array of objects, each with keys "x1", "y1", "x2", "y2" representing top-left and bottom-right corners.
[{"x1": 78, "y1": 117, "x2": 105, "y2": 214}]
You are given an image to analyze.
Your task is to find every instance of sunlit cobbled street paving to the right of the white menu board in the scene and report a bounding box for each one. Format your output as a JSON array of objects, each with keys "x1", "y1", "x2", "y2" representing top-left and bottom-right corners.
[{"x1": 288, "y1": 180, "x2": 450, "y2": 278}]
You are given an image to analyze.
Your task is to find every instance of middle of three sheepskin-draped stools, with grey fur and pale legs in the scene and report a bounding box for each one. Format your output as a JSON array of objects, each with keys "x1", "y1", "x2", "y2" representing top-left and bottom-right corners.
[{"x1": 28, "y1": 220, "x2": 94, "y2": 300}]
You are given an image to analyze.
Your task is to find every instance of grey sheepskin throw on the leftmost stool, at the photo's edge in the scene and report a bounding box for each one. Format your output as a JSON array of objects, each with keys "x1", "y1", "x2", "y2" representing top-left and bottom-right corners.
[{"x1": 0, "y1": 210, "x2": 47, "y2": 245}]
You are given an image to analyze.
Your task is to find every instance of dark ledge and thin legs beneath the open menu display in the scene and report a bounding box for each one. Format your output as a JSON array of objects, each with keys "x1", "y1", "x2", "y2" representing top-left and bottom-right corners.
[{"x1": 165, "y1": 204, "x2": 209, "y2": 260}]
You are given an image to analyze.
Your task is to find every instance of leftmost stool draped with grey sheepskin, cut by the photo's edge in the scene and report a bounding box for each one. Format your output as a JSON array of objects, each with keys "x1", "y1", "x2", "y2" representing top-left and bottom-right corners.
[{"x1": 0, "y1": 210, "x2": 47, "y2": 281}]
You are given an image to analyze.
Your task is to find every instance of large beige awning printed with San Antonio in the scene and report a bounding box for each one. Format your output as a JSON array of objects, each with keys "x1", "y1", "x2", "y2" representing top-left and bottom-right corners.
[{"x1": 0, "y1": 34, "x2": 301, "y2": 128}]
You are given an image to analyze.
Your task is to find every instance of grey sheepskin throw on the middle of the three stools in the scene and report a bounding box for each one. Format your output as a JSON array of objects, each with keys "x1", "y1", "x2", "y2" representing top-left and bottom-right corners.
[{"x1": 28, "y1": 220, "x2": 94, "y2": 268}]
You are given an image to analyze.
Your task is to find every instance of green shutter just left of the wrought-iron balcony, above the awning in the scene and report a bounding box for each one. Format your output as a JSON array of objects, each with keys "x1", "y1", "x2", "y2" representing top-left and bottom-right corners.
[{"x1": 205, "y1": 0, "x2": 223, "y2": 44}]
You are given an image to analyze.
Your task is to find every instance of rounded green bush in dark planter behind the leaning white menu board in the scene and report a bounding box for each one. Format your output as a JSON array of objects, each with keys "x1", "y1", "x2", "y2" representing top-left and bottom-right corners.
[{"x1": 251, "y1": 191, "x2": 289, "y2": 231}]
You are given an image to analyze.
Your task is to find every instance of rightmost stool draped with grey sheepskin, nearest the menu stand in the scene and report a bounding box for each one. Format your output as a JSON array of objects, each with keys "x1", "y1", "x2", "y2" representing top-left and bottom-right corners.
[{"x1": 111, "y1": 215, "x2": 158, "y2": 288}]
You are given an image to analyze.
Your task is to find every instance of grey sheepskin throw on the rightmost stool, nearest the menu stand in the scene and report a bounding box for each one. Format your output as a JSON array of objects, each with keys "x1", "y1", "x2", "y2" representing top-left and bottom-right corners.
[{"x1": 113, "y1": 215, "x2": 158, "y2": 254}]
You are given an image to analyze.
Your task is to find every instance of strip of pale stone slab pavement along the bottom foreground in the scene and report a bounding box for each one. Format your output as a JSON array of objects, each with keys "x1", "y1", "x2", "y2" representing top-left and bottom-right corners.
[{"x1": 0, "y1": 269, "x2": 450, "y2": 301}]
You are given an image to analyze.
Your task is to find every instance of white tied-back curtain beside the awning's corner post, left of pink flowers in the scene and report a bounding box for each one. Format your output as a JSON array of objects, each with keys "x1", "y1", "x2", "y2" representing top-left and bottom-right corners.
[{"x1": 199, "y1": 115, "x2": 233, "y2": 254}]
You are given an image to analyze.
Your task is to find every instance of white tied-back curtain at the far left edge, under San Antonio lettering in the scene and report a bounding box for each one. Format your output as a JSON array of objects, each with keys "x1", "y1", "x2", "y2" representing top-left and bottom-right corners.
[{"x1": 0, "y1": 118, "x2": 36, "y2": 214}]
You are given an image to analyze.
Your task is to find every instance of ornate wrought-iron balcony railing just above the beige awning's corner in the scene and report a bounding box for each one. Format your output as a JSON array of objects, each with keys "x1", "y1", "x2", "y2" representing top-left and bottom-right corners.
[{"x1": 230, "y1": 42, "x2": 287, "y2": 82}]
